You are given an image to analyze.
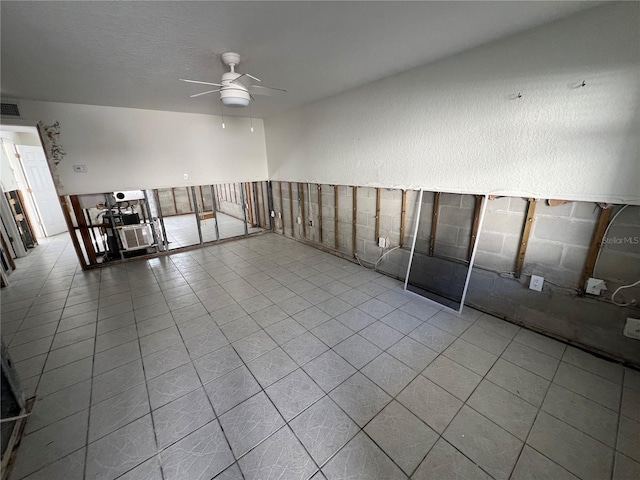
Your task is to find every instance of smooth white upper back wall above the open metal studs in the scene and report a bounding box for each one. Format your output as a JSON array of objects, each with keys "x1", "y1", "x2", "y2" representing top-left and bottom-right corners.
[{"x1": 12, "y1": 100, "x2": 267, "y2": 194}]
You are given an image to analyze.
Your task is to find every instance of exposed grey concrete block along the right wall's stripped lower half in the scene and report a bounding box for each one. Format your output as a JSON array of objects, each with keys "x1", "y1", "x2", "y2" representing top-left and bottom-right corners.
[{"x1": 273, "y1": 183, "x2": 640, "y2": 366}]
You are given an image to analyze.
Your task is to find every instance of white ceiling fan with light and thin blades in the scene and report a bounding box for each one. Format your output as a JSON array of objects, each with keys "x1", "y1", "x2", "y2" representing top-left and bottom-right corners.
[{"x1": 180, "y1": 52, "x2": 286, "y2": 107}]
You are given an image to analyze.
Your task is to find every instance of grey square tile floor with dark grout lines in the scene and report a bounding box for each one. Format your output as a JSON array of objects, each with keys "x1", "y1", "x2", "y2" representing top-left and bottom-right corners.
[{"x1": 2, "y1": 234, "x2": 640, "y2": 480}]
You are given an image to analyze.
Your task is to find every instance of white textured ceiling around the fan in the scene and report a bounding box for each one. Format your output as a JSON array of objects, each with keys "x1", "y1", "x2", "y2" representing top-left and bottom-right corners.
[{"x1": 0, "y1": 0, "x2": 600, "y2": 117}]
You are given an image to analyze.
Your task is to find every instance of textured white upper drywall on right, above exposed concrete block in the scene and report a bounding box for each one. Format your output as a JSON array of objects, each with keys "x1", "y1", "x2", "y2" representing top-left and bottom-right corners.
[{"x1": 265, "y1": 2, "x2": 640, "y2": 203}]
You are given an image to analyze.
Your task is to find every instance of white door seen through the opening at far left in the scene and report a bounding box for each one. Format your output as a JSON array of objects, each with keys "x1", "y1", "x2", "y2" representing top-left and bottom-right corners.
[{"x1": 18, "y1": 145, "x2": 67, "y2": 237}]
